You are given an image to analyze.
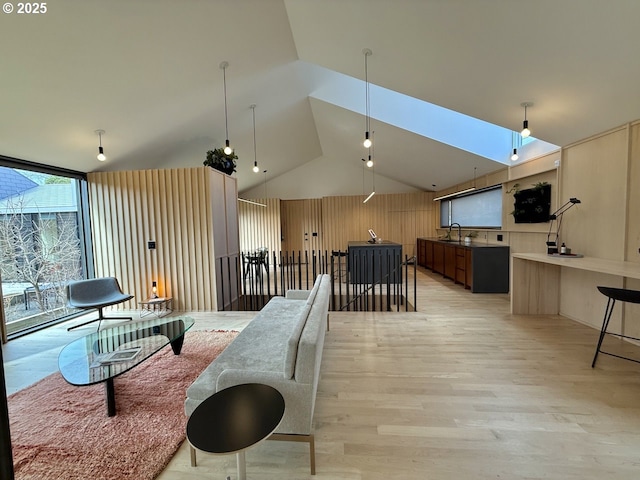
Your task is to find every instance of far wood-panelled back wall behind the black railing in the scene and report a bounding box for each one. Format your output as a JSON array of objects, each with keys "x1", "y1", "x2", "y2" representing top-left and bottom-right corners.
[{"x1": 240, "y1": 192, "x2": 439, "y2": 255}]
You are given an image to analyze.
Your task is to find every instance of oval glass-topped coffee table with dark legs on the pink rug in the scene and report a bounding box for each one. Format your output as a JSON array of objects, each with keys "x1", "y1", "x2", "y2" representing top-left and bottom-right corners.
[{"x1": 58, "y1": 317, "x2": 194, "y2": 417}]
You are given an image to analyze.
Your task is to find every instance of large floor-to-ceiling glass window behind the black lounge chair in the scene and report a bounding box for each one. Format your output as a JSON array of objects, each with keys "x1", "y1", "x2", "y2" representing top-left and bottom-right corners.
[{"x1": 0, "y1": 163, "x2": 91, "y2": 338}]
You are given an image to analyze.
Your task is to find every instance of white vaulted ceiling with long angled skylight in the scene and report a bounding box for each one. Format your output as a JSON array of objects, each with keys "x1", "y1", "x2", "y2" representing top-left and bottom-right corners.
[{"x1": 0, "y1": 0, "x2": 640, "y2": 196}]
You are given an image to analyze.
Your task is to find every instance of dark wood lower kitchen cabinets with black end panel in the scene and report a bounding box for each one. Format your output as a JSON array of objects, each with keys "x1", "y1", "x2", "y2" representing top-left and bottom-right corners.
[{"x1": 417, "y1": 238, "x2": 509, "y2": 293}]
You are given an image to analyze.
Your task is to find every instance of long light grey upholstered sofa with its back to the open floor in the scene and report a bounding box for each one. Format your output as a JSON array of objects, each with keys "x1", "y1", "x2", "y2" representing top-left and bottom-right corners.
[{"x1": 185, "y1": 274, "x2": 331, "y2": 475}]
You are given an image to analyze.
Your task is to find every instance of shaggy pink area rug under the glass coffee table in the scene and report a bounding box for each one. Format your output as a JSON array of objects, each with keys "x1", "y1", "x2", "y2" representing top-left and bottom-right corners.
[{"x1": 9, "y1": 331, "x2": 237, "y2": 480}]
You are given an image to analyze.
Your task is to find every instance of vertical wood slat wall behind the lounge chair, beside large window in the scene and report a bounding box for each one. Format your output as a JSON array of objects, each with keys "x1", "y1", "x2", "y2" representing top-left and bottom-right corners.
[{"x1": 88, "y1": 167, "x2": 224, "y2": 311}]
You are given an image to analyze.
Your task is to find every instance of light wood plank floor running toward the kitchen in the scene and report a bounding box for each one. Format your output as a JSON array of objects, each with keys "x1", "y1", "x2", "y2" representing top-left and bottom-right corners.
[{"x1": 5, "y1": 271, "x2": 640, "y2": 480}]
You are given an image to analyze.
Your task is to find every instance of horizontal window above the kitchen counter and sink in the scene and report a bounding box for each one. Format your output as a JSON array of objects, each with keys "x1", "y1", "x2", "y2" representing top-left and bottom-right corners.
[{"x1": 440, "y1": 185, "x2": 502, "y2": 228}]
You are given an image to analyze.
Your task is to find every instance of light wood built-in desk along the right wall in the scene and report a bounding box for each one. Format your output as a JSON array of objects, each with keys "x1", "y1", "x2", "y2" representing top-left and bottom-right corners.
[{"x1": 510, "y1": 253, "x2": 640, "y2": 315}]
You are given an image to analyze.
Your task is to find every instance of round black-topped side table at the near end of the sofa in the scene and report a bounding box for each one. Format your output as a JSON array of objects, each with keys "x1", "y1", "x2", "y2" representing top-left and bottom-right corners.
[{"x1": 187, "y1": 383, "x2": 284, "y2": 480}]
